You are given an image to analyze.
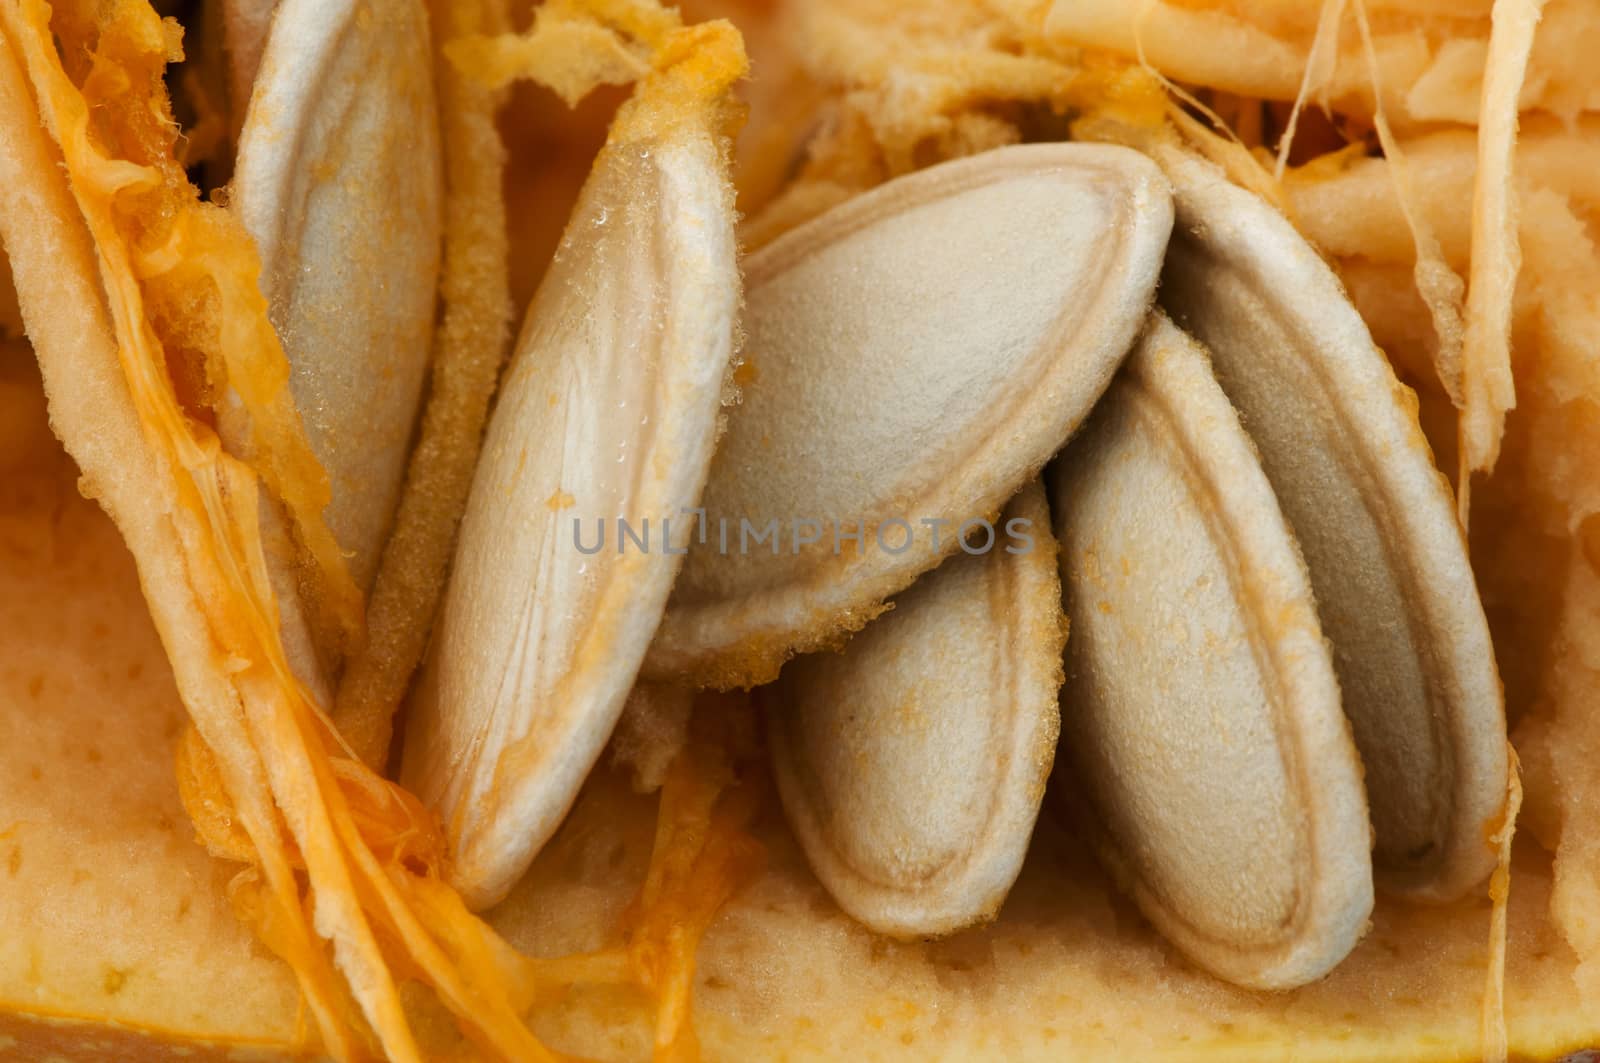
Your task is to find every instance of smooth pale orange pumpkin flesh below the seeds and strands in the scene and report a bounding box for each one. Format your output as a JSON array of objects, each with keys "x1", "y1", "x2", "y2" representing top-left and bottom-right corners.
[{"x1": 0, "y1": 344, "x2": 1600, "y2": 1060}]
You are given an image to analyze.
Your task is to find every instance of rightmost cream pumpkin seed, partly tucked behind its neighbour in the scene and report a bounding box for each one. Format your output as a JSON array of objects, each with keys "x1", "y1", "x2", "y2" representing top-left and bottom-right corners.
[{"x1": 1160, "y1": 150, "x2": 1507, "y2": 900}]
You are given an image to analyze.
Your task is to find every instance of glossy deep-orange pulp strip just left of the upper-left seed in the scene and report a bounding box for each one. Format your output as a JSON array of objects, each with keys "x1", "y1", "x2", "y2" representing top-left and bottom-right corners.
[{"x1": 37, "y1": 0, "x2": 362, "y2": 637}]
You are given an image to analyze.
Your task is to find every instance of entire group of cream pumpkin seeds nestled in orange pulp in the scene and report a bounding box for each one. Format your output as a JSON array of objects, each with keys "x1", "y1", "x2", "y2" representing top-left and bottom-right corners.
[{"x1": 235, "y1": 5, "x2": 1507, "y2": 988}]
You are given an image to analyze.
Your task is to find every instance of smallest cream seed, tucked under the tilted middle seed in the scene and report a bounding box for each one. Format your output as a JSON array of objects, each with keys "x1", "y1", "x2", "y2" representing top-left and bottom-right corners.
[{"x1": 762, "y1": 480, "x2": 1067, "y2": 938}]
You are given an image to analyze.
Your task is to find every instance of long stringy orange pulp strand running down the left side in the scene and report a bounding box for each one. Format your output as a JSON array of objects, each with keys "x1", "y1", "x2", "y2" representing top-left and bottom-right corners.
[{"x1": 8, "y1": 0, "x2": 541, "y2": 1060}]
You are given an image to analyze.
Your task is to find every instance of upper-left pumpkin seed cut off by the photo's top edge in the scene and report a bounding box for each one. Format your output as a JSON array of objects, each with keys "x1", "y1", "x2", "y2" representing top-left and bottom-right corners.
[{"x1": 232, "y1": 0, "x2": 443, "y2": 589}]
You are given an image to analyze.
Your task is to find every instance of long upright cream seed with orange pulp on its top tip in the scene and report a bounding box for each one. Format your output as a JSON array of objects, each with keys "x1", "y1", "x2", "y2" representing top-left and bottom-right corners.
[{"x1": 403, "y1": 120, "x2": 739, "y2": 906}]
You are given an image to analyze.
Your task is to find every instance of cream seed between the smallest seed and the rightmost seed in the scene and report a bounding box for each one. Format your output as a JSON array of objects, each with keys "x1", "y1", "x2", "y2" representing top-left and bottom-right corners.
[{"x1": 1051, "y1": 315, "x2": 1373, "y2": 988}]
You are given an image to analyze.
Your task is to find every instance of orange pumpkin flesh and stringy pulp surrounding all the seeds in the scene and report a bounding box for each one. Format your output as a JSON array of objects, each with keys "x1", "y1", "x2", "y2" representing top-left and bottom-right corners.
[{"x1": 0, "y1": 0, "x2": 1600, "y2": 1060}]
